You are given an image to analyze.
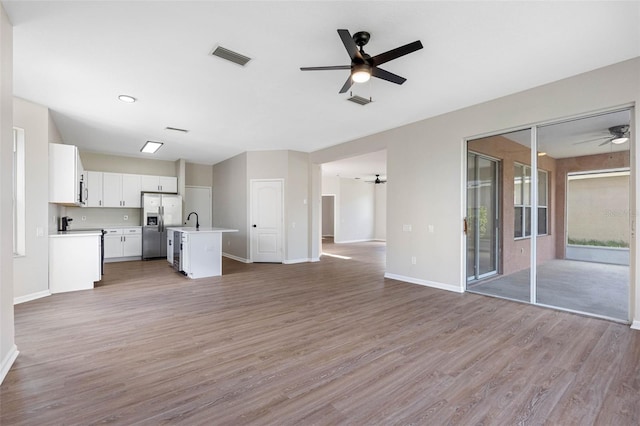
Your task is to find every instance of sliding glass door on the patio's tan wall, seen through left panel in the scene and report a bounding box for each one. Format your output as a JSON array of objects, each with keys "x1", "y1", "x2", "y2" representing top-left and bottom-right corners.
[{"x1": 466, "y1": 152, "x2": 499, "y2": 281}]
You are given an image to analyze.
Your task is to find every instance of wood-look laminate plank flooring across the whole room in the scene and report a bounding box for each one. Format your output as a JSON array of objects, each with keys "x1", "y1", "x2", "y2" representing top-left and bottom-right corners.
[{"x1": 0, "y1": 242, "x2": 640, "y2": 425}]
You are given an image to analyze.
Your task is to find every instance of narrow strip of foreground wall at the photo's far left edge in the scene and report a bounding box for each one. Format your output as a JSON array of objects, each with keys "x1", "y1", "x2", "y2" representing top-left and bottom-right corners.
[{"x1": 0, "y1": 4, "x2": 18, "y2": 383}]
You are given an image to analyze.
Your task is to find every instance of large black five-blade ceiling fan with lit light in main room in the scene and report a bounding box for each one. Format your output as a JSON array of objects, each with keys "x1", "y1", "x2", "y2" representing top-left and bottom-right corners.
[{"x1": 300, "y1": 30, "x2": 422, "y2": 93}]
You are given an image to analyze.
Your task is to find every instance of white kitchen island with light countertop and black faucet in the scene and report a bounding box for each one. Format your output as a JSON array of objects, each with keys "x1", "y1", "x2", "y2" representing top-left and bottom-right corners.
[{"x1": 167, "y1": 227, "x2": 238, "y2": 279}]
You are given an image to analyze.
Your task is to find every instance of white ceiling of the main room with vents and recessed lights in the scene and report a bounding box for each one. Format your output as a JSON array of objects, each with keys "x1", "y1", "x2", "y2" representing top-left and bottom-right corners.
[{"x1": 2, "y1": 0, "x2": 640, "y2": 170}]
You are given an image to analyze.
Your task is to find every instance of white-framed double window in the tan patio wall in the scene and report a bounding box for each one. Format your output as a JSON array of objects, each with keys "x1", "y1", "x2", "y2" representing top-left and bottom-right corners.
[{"x1": 513, "y1": 163, "x2": 549, "y2": 238}]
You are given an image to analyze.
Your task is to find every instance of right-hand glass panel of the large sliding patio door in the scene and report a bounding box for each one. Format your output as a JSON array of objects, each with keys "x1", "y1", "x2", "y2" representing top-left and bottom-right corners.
[{"x1": 535, "y1": 110, "x2": 631, "y2": 321}]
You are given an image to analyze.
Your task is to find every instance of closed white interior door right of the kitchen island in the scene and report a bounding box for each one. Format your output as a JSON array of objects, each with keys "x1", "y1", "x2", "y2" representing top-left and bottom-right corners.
[{"x1": 250, "y1": 180, "x2": 284, "y2": 263}]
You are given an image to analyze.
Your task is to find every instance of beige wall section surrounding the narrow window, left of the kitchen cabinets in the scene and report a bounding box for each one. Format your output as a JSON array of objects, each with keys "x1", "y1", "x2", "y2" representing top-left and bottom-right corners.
[{"x1": 13, "y1": 98, "x2": 51, "y2": 302}]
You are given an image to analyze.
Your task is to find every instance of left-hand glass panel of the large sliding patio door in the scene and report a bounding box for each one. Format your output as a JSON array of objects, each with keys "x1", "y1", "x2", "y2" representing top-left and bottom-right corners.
[{"x1": 467, "y1": 129, "x2": 532, "y2": 302}]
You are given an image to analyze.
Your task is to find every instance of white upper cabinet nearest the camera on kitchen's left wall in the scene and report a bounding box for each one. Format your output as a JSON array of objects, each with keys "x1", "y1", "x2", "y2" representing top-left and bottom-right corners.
[{"x1": 49, "y1": 143, "x2": 86, "y2": 206}]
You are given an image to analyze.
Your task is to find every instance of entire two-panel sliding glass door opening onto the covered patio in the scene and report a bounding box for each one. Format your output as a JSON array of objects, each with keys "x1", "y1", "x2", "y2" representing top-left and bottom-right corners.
[{"x1": 465, "y1": 109, "x2": 632, "y2": 322}]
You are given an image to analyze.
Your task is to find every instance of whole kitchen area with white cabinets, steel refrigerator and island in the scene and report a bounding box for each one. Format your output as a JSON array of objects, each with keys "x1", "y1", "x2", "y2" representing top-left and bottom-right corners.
[{"x1": 49, "y1": 140, "x2": 236, "y2": 293}]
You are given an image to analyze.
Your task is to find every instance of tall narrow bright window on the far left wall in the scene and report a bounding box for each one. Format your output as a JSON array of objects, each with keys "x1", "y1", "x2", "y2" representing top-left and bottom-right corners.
[{"x1": 13, "y1": 128, "x2": 25, "y2": 256}]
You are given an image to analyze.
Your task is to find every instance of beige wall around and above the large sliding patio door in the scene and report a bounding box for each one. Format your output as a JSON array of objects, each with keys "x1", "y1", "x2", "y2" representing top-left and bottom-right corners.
[{"x1": 311, "y1": 58, "x2": 640, "y2": 327}]
